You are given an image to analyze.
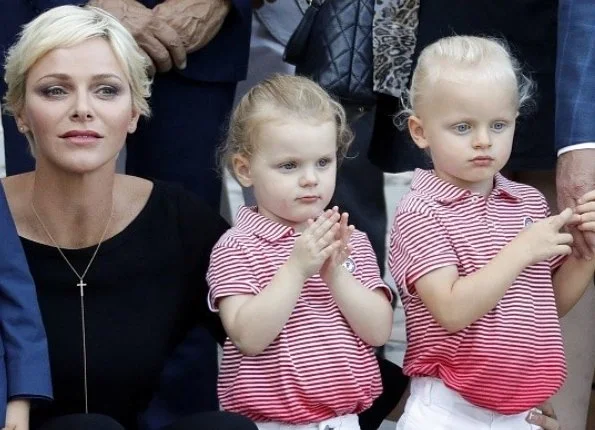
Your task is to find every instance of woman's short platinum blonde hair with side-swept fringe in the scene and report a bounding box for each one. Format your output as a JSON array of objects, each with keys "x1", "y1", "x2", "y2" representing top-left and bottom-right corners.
[{"x1": 4, "y1": 6, "x2": 151, "y2": 120}]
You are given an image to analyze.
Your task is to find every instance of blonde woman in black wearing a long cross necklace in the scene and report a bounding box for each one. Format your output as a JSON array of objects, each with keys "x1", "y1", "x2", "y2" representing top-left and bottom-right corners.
[{"x1": 3, "y1": 6, "x2": 255, "y2": 430}]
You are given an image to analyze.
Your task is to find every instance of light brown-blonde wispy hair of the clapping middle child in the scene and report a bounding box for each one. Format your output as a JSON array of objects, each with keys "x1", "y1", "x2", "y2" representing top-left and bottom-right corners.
[{"x1": 218, "y1": 74, "x2": 353, "y2": 177}]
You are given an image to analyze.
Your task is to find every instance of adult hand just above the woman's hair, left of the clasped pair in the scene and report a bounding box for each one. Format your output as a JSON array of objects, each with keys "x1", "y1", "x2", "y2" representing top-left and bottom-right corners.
[{"x1": 88, "y1": 0, "x2": 186, "y2": 72}]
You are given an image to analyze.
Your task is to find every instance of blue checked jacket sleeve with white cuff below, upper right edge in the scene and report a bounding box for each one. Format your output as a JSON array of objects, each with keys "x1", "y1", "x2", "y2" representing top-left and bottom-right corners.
[{"x1": 556, "y1": 0, "x2": 595, "y2": 150}]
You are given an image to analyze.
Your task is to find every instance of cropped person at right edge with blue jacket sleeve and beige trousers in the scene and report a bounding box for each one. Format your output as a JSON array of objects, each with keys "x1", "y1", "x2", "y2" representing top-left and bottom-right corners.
[{"x1": 555, "y1": 0, "x2": 595, "y2": 424}]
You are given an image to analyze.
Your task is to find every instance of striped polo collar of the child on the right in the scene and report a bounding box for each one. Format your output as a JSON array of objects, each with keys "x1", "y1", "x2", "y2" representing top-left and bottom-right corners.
[{"x1": 411, "y1": 169, "x2": 522, "y2": 204}]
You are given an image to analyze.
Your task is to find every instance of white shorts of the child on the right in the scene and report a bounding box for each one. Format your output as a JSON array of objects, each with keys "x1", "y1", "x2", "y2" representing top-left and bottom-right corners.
[{"x1": 397, "y1": 377, "x2": 541, "y2": 430}]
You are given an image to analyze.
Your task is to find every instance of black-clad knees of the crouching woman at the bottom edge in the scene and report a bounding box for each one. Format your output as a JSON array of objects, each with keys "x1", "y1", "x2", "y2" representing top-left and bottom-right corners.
[{"x1": 38, "y1": 412, "x2": 257, "y2": 430}]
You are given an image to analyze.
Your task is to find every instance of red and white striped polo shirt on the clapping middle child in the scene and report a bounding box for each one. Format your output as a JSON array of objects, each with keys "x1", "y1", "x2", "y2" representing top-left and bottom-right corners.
[{"x1": 207, "y1": 207, "x2": 390, "y2": 424}]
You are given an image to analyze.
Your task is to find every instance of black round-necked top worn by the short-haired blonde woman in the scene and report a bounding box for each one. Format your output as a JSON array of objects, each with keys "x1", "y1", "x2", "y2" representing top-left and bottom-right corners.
[{"x1": 21, "y1": 182, "x2": 228, "y2": 430}]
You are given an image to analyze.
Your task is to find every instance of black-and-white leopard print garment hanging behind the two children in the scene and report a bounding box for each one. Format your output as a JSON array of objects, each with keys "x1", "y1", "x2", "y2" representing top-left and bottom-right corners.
[{"x1": 373, "y1": 0, "x2": 420, "y2": 97}]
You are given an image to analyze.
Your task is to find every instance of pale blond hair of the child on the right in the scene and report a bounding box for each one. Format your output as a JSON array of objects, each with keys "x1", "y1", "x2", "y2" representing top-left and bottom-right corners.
[{"x1": 400, "y1": 36, "x2": 534, "y2": 116}]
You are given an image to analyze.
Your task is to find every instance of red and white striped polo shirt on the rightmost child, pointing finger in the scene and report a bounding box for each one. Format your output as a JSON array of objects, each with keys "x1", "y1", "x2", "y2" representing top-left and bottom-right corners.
[{"x1": 389, "y1": 169, "x2": 566, "y2": 414}]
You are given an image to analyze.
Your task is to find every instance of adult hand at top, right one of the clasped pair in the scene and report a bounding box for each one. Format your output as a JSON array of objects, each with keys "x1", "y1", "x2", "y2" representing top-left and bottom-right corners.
[{"x1": 153, "y1": 0, "x2": 231, "y2": 53}]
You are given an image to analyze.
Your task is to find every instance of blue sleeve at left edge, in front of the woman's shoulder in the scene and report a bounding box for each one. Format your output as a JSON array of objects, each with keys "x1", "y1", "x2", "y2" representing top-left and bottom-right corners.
[{"x1": 0, "y1": 186, "x2": 52, "y2": 399}]
